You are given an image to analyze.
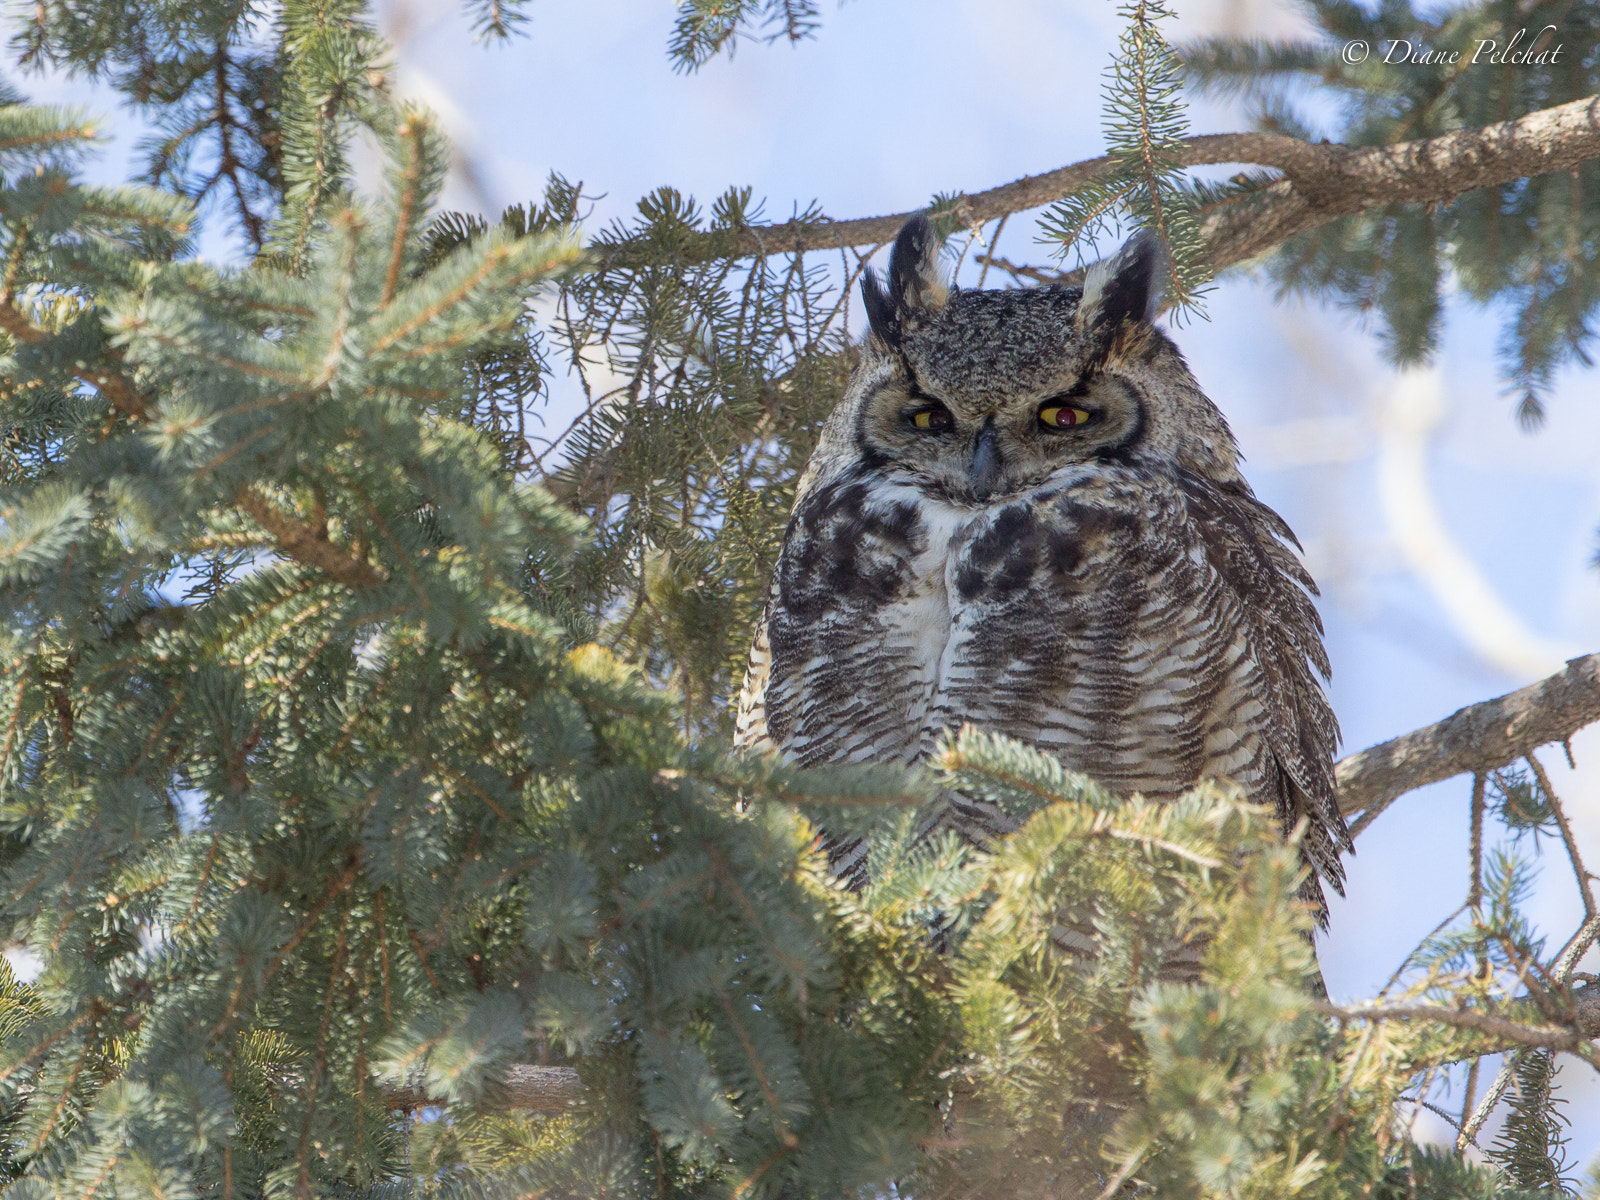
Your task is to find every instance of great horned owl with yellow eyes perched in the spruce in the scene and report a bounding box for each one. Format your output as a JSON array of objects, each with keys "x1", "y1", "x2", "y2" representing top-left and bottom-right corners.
[{"x1": 736, "y1": 218, "x2": 1350, "y2": 912}]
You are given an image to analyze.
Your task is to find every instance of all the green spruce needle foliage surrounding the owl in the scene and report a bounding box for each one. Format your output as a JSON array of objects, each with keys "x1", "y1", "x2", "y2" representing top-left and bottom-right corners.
[{"x1": 0, "y1": 0, "x2": 1600, "y2": 1200}]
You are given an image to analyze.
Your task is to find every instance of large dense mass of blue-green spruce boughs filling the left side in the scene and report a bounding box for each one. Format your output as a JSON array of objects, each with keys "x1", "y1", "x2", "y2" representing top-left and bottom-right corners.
[{"x1": 0, "y1": 101, "x2": 960, "y2": 1195}]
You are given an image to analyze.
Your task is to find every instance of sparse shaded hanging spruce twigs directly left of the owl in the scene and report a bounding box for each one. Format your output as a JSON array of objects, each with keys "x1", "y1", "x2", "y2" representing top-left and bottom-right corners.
[{"x1": 534, "y1": 191, "x2": 859, "y2": 730}]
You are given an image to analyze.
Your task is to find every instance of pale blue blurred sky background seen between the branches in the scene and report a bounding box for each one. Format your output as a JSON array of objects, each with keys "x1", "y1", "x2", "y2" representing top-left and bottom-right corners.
[{"x1": 31, "y1": 0, "x2": 1600, "y2": 1163}]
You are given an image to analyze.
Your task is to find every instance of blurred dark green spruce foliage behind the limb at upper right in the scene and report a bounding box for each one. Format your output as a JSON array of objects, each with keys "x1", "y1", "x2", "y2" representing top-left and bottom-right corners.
[{"x1": 1182, "y1": 0, "x2": 1600, "y2": 421}]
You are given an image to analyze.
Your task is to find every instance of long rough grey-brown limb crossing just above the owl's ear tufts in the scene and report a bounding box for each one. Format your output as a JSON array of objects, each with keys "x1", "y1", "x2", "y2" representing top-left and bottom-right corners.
[{"x1": 597, "y1": 98, "x2": 1600, "y2": 278}]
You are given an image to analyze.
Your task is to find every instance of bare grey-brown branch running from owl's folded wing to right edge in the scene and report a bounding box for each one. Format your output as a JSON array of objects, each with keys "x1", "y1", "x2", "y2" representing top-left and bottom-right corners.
[{"x1": 1336, "y1": 654, "x2": 1600, "y2": 816}]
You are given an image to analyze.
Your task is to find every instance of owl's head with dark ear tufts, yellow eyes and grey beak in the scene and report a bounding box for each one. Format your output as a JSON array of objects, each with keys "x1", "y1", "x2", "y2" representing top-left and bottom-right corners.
[{"x1": 824, "y1": 216, "x2": 1238, "y2": 506}]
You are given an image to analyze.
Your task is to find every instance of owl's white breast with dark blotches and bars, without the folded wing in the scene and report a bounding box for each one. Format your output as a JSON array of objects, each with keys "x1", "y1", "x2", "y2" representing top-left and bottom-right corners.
[{"x1": 741, "y1": 470, "x2": 1259, "y2": 795}]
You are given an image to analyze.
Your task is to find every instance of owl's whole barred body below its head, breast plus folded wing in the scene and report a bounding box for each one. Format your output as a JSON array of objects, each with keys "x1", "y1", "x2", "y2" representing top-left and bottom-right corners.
[{"x1": 736, "y1": 464, "x2": 1349, "y2": 910}]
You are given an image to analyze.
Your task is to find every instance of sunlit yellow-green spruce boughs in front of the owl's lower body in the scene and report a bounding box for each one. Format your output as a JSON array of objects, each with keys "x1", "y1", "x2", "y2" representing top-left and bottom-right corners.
[{"x1": 864, "y1": 731, "x2": 1560, "y2": 1200}]
